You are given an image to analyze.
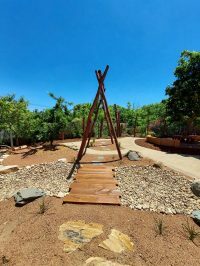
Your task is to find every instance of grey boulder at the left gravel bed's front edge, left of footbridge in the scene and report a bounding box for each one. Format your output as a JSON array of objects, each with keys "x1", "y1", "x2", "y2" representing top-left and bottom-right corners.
[{"x1": 14, "y1": 188, "x2": 45, "y2": 206}]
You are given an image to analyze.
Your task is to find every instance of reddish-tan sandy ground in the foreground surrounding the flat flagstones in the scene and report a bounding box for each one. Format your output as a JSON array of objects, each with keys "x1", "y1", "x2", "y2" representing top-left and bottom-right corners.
[{"x1": 0, "y1": 198, "x2": 200, "y2": 266}]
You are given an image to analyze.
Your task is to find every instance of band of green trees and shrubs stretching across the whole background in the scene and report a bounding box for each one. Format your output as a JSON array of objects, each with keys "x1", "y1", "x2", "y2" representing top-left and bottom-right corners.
[{"x1": 0, "y1": 51, "x2": 200, "y2": 145}]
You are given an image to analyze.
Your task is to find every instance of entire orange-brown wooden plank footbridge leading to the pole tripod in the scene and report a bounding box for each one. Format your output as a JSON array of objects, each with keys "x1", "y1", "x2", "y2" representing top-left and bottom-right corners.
[{"x1": 63, "y1": 165, "x2": 120, "y2": 205}]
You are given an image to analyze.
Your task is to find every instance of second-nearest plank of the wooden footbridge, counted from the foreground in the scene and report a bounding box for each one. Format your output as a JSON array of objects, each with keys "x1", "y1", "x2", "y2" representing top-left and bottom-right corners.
[{"x1": 70, "y1": 186, "x2": 120, "y2": 196}]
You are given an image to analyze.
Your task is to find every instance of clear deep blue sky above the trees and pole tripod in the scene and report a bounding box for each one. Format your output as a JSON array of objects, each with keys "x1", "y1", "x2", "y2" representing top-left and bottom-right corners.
[{"x1": 0, "y1": 0, "x2": 200, "y2": 109}]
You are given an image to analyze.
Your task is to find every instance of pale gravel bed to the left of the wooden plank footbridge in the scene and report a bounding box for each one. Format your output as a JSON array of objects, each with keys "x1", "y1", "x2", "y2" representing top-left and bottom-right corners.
[{"x1": 0, "y1": 162, "x2": 75, "y2": 200}]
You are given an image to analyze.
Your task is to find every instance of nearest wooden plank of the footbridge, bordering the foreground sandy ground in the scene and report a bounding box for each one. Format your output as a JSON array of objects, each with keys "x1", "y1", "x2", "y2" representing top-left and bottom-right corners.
[{"x1": 63, "y1": 194, "x2": 120, "y2": 205}]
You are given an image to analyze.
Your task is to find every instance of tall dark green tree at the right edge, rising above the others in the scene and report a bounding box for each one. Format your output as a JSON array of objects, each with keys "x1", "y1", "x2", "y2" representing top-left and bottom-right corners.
[{"x1": 166, "y1": 51, "x2": 200, "y2": 134}]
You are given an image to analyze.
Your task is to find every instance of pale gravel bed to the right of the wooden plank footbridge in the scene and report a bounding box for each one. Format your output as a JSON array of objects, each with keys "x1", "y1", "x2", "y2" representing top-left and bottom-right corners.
[{"x1": 116, "y1": 166, "x2": 200, "y2": 214}]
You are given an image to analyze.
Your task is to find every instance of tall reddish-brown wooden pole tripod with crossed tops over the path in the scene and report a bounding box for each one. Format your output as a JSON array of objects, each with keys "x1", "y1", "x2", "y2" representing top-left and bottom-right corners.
[{"x1": 77, "y1": 66, "x2": 122, "y2": 162}]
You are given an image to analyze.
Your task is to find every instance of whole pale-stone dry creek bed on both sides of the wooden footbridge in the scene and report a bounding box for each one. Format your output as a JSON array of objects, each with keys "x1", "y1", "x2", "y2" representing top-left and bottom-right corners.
[{"x1": 0, "y1": 162, "x2": 200, "y2": 214}]
